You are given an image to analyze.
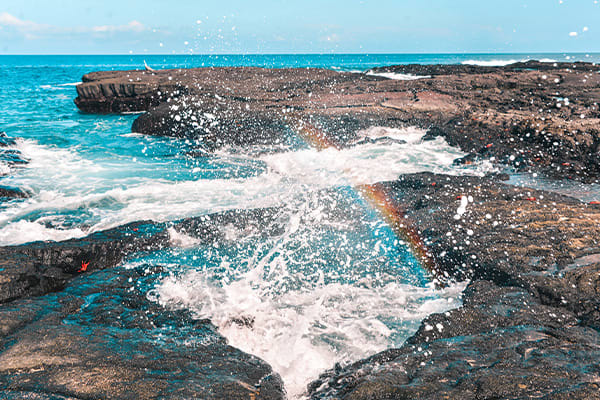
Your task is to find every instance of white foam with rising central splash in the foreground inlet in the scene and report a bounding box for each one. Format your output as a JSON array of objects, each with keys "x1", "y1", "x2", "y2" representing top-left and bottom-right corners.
[{"x1": 149, "y1": 225, "x2": 465, "y2": 398}]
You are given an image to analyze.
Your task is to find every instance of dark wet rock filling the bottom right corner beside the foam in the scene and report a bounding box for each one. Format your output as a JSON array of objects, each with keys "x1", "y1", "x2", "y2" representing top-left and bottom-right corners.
[{"x1": 311, "y1": 282, "x2": 600, "y2": 400}]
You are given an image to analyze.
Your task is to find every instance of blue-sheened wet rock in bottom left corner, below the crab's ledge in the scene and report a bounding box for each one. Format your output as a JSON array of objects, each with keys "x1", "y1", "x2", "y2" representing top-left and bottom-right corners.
[{"x1": 0, "y1": 267, "x2": 284, "y2": 399}]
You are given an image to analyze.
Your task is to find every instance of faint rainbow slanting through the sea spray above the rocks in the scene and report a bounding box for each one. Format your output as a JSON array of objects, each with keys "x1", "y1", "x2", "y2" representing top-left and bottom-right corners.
[{"x1": 288, "y1": 115, "x2": 438, "y2": 274}]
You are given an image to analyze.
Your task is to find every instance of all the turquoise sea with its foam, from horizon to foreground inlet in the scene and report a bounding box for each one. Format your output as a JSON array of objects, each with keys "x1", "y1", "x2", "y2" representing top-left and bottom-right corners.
[{"x1": 0, "y1": 54, "x2": 600, "y2": 395}]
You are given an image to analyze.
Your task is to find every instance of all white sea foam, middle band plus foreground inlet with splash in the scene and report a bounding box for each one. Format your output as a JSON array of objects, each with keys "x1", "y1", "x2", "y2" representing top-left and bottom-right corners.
[{"x1": 0, "y1": 127, "x2": 476, "y2": 398}]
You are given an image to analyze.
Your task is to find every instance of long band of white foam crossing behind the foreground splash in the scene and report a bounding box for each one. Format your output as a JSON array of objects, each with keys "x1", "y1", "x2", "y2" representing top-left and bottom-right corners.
[{"x1": 0, "y1": 128, "x2": 486, "y2": 245}]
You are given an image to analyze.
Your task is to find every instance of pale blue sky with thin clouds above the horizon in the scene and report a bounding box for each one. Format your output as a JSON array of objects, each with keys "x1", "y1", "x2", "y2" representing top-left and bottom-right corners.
[{"x1": 0, "y1": 0, "x2": 600, "y2": 54}]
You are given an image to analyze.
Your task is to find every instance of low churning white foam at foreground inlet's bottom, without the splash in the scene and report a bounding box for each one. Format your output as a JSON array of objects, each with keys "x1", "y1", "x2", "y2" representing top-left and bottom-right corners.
[{"x1": 152, "y1": 264, "x2": 465, "y2": 398}]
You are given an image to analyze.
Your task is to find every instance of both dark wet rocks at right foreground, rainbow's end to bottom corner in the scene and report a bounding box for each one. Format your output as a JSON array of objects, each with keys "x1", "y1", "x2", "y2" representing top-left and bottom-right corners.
[{"x1": 310, "y1": 174, "x2": 600, "y2": 399}]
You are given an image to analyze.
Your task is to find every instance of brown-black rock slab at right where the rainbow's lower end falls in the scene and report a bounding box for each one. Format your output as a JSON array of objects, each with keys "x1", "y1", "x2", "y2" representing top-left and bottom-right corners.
[{"x1": 383, "y1": 174, "x2": 600, "y2": 327}]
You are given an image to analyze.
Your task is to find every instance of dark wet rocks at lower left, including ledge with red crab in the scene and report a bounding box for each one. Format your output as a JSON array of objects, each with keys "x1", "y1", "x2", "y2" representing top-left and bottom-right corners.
[{"x1": 0, "y1": 209, "x2": 285, "y2": 399}]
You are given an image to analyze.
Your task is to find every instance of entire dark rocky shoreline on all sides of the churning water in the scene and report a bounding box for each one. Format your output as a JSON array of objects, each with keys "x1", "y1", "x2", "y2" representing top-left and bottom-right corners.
[{"x1": 0, "y1": 62, "x2": 600, "y2": 399}]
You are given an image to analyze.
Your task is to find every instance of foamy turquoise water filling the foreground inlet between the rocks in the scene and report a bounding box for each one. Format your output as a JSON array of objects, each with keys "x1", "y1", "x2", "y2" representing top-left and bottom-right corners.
[{"x1": 148, "y1": 192, "x2": 465, "y2": 398}]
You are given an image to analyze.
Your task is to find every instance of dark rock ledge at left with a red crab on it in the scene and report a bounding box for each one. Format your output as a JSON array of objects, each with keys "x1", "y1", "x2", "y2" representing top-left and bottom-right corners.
[{"x1": 0, "y1": 208, "x2": 279, "y2": 303}]
